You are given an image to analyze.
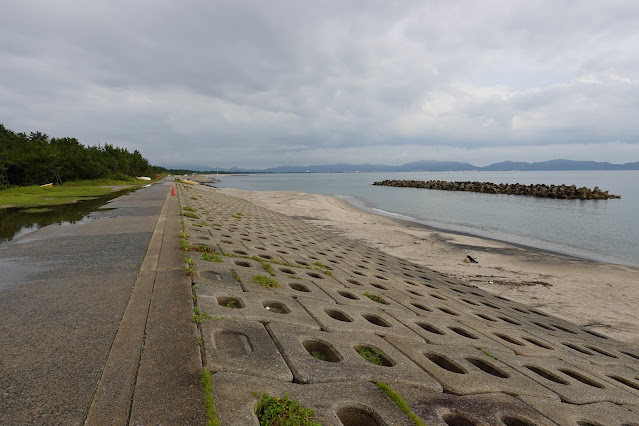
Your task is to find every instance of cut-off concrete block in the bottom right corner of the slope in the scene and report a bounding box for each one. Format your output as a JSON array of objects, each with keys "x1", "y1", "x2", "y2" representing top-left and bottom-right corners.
[{"x1": 518, "y1": 396, "x2": 639, "y2": 425}]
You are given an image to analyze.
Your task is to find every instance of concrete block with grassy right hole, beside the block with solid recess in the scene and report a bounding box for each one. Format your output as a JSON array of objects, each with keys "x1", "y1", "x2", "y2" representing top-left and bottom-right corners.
[{"x1": 267, "y1": 323, "x2": 442, "y2": 391}]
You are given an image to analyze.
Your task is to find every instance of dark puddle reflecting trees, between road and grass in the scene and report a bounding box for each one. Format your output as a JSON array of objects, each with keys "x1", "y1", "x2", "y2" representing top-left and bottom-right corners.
[{"x1": 0, "y1": 188, "x2": 138, "y2": 244}]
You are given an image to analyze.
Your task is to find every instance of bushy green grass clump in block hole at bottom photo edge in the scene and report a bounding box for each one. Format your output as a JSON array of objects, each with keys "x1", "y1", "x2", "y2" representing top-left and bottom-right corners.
[{"x1": 255, "y1": 392, "x2": 321, "y2": 426}]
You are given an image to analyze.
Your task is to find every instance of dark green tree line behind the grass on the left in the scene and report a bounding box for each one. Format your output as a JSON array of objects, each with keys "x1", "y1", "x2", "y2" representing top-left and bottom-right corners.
[{"x1": 0, "y1": 124, "x2": 158, "y2": 187}]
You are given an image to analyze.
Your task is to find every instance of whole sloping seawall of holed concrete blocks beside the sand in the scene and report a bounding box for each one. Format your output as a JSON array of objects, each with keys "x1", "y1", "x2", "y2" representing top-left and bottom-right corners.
[{"x1": 179, "y1": 184, "x2": 639, "y2": 425}]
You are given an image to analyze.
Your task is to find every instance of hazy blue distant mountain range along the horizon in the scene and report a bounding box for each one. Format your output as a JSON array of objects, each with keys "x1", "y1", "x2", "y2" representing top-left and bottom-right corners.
[{"x1": 187, "y1": 160, "x2": 639, "y2": 173}]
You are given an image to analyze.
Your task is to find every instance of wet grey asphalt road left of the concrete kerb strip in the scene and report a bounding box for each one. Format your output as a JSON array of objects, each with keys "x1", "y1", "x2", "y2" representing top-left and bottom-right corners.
[{"x1": 0, "y1": 180, "x2": 171, "y2": 425}]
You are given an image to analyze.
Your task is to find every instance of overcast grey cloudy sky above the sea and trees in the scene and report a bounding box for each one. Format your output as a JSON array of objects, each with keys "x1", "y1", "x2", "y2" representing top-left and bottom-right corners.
[{"x1": 0, "y1": 0, "x2": 639, "y2": 168}]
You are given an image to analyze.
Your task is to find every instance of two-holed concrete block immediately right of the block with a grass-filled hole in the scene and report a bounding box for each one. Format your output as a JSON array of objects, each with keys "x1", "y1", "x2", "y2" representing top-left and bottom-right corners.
[{"x1": 385, "y1": 336, "x2": 559, "y2": 399}]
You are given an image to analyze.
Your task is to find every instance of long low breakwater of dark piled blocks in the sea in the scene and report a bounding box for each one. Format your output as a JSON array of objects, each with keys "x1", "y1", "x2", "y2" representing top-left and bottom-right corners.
[{"x1": 373, "y1": 180, "x2": 621, "y2": 200}]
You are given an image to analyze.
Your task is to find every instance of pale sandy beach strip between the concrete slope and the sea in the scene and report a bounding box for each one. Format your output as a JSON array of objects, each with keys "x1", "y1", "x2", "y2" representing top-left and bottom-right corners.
[{"x1": 220, "y1": 188, "x2": 639, "y2": 344}]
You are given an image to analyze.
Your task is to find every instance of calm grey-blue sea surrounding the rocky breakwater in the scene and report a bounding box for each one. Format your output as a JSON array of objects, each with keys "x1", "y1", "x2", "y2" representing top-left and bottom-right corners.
[{"x1": 215, "y1": 171, "x2": 639, "y2": 266}]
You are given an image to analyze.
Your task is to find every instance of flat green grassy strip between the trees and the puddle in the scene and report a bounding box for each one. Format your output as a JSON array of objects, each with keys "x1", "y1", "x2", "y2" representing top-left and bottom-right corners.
[{"x1": 0, "y1": 178, "x2": 157, "y2": 208}]
